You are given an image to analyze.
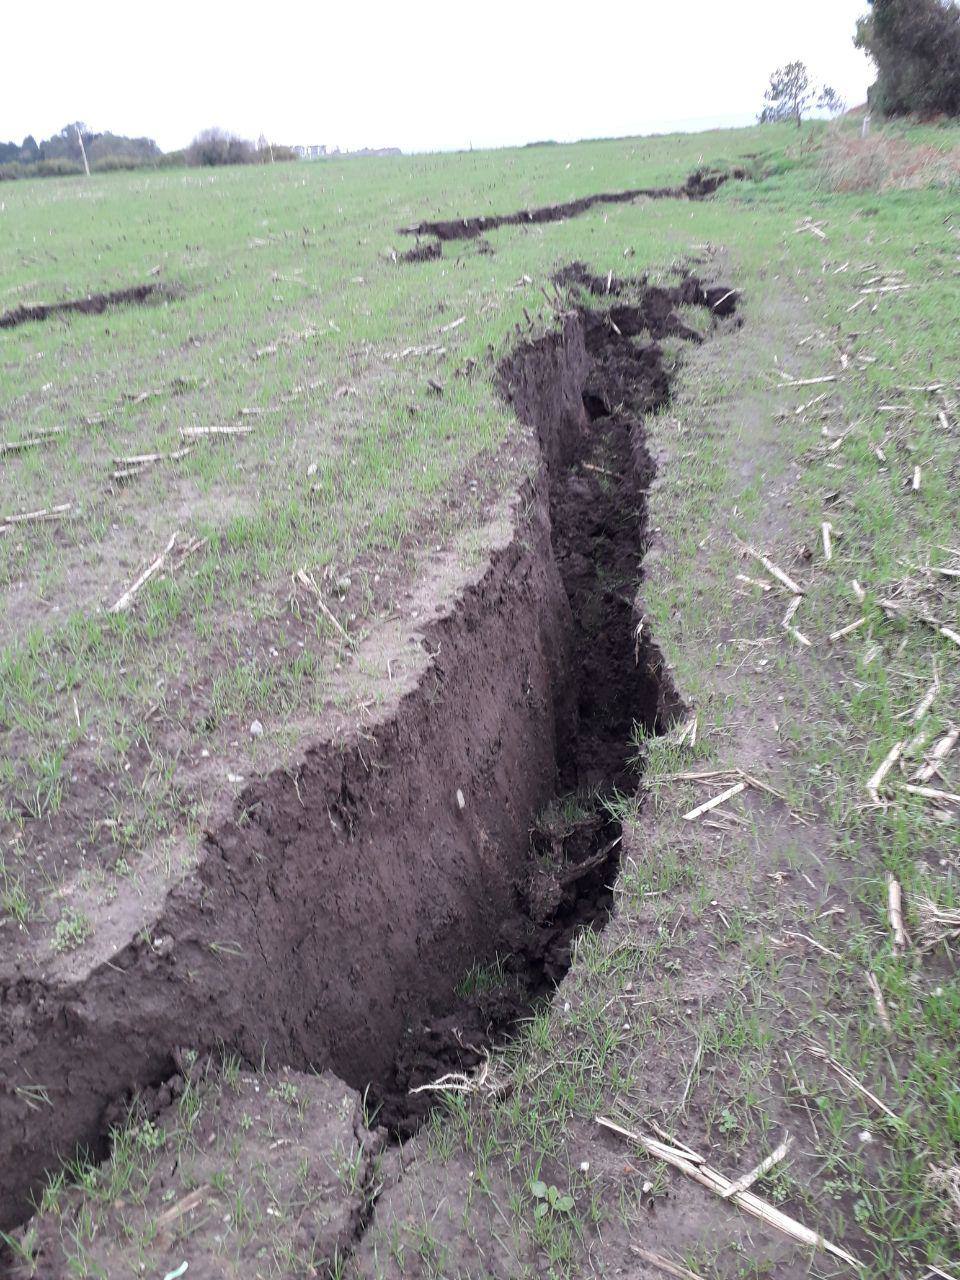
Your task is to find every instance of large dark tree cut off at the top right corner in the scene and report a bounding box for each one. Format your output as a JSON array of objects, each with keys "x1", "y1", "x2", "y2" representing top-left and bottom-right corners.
[{"x1": 854, "y1": 0, "x2": 960, "y2": 115}]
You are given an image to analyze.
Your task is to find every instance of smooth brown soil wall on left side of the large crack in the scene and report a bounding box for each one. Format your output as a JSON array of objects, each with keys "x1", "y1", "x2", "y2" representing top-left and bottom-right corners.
[{"x1": 0, "y1": 335, "x2": 586, "y2": 1225}]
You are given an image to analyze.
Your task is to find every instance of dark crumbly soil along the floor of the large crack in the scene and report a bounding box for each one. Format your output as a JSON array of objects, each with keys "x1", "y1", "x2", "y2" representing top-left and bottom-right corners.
[{"x1": 375, "y1": 268, "x2": 726, "y2": 1134}]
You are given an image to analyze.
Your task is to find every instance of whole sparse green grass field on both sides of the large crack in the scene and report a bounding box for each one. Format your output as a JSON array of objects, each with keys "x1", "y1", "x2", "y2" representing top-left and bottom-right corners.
[{"x1": 0, "y1": 115, "x2": 960, "y2": 1280}]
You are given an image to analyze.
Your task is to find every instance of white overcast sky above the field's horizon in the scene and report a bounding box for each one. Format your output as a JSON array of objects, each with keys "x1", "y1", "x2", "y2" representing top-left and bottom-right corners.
[{"x1": 0, "y1": 0, "x2": 873, "y2": 151}]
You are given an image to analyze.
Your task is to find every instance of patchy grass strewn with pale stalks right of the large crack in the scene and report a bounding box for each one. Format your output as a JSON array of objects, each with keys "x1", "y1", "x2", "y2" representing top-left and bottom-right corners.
[{"x1": 348, "y1": 122, "x2": 960, "y2": 1280}]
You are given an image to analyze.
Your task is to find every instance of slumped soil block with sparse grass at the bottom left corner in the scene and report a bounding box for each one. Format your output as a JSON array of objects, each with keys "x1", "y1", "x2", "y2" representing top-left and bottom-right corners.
[{"x1": 4, "y1": 1059, "x2": 380, "y2": 1280}]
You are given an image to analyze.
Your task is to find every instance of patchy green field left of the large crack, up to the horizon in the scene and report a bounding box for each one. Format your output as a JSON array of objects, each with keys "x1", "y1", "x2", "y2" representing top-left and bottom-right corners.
[{"x1": 0, "y1": 122, "x2": 787, "y2": 956}]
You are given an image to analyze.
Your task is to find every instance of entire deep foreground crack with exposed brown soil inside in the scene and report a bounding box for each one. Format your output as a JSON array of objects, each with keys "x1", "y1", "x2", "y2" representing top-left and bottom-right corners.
[{"x1": 0, "y1": 269, "x2": 733, "y2": 1228}]
